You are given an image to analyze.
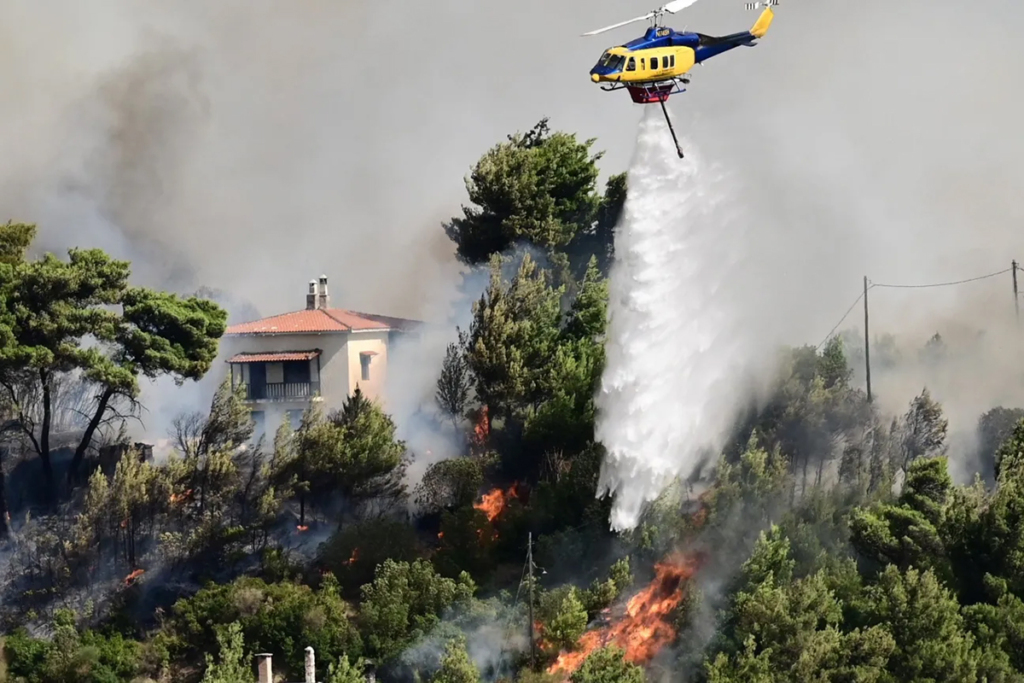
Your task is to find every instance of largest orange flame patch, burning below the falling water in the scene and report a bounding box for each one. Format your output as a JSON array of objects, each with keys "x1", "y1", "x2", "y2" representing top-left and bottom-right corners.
[{"x1": 548, "y1": 554, "x2": 700, "y2": 676}]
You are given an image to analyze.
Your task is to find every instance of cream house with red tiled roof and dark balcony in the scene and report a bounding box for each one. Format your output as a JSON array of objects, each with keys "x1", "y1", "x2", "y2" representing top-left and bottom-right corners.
[{"x1": 221, "y1": 275, "x2": 421, "y2": 438}]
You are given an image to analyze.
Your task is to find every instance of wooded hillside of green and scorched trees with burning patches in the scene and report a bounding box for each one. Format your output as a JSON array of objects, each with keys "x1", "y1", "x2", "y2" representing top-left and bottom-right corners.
[{"x1": 0, "y1": 121, "x2": 1024, "y2": 683}]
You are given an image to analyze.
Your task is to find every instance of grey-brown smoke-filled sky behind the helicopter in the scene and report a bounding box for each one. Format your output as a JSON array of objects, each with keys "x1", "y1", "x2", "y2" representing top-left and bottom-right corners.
[{"x1": 0, "y1": 0, "x2": 1024, "y2": 444}]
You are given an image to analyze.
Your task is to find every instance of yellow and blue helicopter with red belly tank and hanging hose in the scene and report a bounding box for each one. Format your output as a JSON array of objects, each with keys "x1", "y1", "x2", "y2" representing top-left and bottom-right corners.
[{"x1": 583, "y1": 0, "x2": 779, "y2": 159}]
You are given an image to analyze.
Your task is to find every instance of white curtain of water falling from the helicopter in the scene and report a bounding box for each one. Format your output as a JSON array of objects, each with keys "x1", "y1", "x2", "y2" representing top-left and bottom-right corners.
[{"x1": 596, "y1": 106, "x2": 770, "y2": 529}]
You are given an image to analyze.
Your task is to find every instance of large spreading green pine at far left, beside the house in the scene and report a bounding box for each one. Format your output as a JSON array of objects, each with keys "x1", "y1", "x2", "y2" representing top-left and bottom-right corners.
[{"x1": 0, "y1": 224, "x2": 227, "y2": 496}]
